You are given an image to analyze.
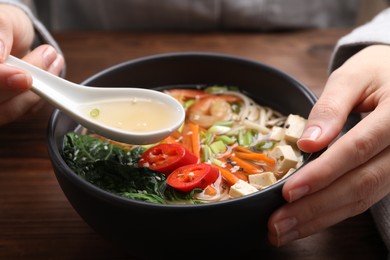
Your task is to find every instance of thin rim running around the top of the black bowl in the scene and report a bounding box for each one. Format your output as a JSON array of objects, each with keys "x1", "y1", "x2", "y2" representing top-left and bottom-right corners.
[{"x1": 47, "y1": 52, "x2": 323, "y2": 210}]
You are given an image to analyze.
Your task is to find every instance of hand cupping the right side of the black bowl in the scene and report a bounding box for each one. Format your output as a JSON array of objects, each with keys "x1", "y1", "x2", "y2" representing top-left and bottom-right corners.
[{"x1": 268, "y1": 45, "x2": 390, "y2": 246}]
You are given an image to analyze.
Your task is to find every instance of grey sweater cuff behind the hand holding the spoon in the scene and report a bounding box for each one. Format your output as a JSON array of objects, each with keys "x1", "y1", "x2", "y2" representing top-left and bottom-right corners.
[{"x1": 0, "y1": 0, "x2": 62, "y2": 54}]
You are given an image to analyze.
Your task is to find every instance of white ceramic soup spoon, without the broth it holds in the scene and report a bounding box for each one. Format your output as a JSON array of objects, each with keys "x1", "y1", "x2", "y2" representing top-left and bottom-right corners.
[{"x1": 5, "y1": 56, "x2": 185, "y2": 144}]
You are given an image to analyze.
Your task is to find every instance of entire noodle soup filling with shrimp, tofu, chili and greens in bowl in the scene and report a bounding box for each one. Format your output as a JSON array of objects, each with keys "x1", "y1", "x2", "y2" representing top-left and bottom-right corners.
[{"x1": 62, "y1": 86, "x2": 306, "y2": 204}]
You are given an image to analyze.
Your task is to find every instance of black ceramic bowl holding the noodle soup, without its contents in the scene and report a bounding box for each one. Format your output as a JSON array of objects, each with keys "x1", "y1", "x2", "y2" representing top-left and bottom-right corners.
[{"x1": 48, "y1": 53, "x2": 319, "y2": 257}]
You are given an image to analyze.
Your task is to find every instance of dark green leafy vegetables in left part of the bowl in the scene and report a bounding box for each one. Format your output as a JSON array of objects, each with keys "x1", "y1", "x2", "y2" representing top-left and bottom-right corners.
[{"x1": 62, "y1": 132, "x2": 204, "y2": 204}]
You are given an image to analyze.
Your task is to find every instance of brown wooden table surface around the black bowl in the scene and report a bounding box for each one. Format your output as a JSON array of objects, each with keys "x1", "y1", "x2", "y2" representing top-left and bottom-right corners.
[{"x1": 0, "y1": 29, "x2": 387, "y2": 260}]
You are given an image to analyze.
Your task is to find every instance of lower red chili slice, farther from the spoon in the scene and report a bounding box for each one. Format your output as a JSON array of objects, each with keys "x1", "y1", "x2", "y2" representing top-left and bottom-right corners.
[{"x1": 167, "y1": 163, "x2": 219, "y2": 192}]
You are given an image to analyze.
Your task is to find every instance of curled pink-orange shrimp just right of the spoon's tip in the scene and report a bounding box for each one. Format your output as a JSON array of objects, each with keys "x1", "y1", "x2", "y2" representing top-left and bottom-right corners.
[{"x1": 187, "y1": 95, "x2": 241, "y2": 128}]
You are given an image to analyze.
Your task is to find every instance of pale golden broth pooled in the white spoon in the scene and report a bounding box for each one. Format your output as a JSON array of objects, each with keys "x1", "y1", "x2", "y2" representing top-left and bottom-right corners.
[{"x1": 80, "y1": 98, "x2": 176, "y2": 132}]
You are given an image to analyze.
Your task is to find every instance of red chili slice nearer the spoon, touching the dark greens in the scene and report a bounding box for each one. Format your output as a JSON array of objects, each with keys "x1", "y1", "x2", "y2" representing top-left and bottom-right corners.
[{"x1": 139, "y1": 143, "x2": 198, "y2": 175}]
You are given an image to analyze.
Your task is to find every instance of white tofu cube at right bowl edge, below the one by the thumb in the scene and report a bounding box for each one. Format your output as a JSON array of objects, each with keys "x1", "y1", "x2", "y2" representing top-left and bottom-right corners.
[{"x1": 269, "y1": 144, "x2": 298, "y2": 178}]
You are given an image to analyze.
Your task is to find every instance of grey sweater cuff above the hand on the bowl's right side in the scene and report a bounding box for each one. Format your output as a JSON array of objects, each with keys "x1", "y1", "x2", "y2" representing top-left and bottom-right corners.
[{"x1": 330, "y1": 8, "x2": 390, "y2": 71}]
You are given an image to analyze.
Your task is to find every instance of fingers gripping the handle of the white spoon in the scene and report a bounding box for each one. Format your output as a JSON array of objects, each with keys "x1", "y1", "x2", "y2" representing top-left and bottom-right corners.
[{"x1": 0, "y1": 4, "x2": 64, "y2": 125}]
